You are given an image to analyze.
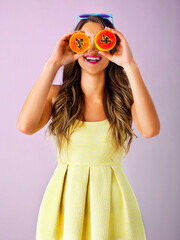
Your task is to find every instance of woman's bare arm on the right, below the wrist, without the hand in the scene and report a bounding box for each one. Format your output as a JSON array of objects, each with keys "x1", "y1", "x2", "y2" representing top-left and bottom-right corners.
[{"x1": 124, "y1": 62, "x2": 160, "y2": 138}]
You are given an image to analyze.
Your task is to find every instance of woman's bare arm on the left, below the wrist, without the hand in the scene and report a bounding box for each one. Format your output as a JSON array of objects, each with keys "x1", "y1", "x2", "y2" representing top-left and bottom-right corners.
[{"x1": 17, "y1": 60, "x2": 59, "y2": 135}]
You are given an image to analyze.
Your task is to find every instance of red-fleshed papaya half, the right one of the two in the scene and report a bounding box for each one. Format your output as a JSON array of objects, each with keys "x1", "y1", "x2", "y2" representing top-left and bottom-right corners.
[{"x1": 94, "y1": 30, "x2": 116, "y2": 51}]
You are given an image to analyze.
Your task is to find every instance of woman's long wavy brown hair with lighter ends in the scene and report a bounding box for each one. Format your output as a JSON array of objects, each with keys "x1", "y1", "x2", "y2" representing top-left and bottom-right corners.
[{"x1": 45, "y1": 16, "x2": 137, "y2": 157}]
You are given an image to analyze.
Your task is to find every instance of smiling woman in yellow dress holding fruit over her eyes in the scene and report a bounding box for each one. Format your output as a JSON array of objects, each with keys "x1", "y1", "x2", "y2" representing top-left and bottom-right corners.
[{"x1": 18, "y1": 15, "x2": 160, "y2": 240}]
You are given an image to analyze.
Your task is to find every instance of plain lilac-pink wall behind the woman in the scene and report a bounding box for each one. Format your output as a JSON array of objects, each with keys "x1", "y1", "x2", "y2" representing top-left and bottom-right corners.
[{"x1": 0, "y1": 0, "x2": 180, "y2": 240}]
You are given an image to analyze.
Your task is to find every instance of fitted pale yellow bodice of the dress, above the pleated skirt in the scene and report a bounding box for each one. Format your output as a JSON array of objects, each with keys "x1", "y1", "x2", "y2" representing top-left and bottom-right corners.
[{"x1": 58, "y1": 119, "x2": 124, "y2": 165}]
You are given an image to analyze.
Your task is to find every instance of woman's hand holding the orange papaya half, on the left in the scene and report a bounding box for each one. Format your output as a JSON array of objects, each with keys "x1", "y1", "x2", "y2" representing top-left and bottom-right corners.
[{"x1": 47, "y1": 31, "x2": 84, "y2": 67}]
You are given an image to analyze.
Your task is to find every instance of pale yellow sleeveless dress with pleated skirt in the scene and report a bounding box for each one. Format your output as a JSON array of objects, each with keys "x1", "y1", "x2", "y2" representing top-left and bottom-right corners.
[{"x1": 36, "y1": 119, "x2": 146, "y2": 240}]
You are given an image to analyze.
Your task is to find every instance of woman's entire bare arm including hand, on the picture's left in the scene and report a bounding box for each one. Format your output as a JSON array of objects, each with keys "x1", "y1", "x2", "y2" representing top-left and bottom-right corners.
[{"x1": 17, "y1": 31, "x2": 87, "y2": 135}]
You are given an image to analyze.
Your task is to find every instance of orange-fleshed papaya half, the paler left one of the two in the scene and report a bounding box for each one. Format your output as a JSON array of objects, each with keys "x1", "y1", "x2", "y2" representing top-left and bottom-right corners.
[{"x1": 69, "y1": 32, "x2": 90, "y2": 53}]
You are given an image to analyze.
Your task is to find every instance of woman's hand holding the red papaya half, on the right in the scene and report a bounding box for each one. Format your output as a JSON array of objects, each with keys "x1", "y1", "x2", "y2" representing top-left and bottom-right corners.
[{"x1": 98, "y1": 27, "x2": 135, "y2": 67}]
